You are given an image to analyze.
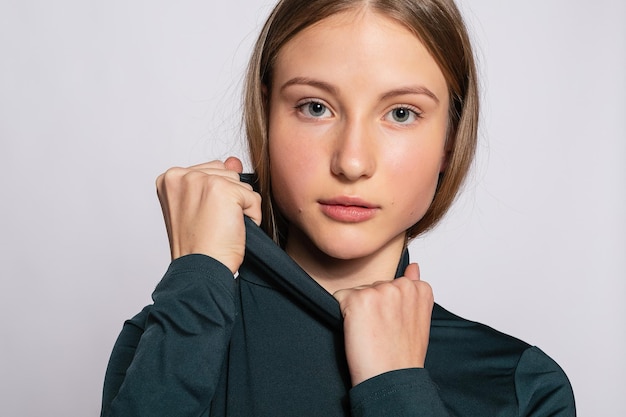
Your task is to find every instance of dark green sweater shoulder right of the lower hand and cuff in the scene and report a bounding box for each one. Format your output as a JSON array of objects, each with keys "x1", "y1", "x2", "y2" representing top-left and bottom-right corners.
[{"x1": 426, "y1": 305, "x2": 574, "y2": 416}]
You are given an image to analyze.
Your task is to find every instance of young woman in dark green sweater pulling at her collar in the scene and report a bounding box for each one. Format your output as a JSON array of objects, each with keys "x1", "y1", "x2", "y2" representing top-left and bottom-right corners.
[{"x1": 102, "y1": 0, "x2": 575, "y2": 417}]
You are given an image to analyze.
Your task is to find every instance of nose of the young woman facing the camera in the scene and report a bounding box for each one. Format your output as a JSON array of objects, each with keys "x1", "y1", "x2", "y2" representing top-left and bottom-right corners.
[{"x1": 331, "y1": 121, "x2": 377, "y2": 181}]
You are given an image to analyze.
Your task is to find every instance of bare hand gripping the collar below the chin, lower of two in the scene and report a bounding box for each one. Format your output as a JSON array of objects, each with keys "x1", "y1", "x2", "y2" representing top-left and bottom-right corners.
[{"x1": 334, "y1": 264, "x2": 434, "y2": 386}]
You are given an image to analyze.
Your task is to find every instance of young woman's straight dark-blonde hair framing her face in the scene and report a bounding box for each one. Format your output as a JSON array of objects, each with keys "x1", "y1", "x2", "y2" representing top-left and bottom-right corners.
[{"x1": 243, "y1": 0, "x2": 479, "y2": 244}]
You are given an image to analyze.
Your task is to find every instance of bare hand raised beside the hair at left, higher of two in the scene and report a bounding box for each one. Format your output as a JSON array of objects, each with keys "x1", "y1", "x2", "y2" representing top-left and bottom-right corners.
[{"x1": 156, "y1": 157, "x2": 261, "y2": 273}]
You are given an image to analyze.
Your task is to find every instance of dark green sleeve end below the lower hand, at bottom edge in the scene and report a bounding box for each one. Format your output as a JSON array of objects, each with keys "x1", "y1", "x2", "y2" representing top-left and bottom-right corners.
[{"x1": 350, "y1": 368, "x2": 450, "y2": 417}]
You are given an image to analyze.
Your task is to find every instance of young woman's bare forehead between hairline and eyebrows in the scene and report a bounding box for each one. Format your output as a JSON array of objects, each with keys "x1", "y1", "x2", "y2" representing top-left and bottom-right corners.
[{"x1": 273, "y1": 8, "x2": 447, "y2": 95}]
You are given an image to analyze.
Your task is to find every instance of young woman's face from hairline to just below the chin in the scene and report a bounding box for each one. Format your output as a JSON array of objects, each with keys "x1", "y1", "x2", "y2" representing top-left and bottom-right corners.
[{"x1": 269, "y1": 10, "x2": 448, "y2": 274}]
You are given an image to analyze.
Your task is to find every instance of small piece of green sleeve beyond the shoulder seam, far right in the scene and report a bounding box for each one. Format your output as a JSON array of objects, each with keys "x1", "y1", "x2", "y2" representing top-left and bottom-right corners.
[{"x1": 515, "y1": 347, "x2": 576, "y2": 417}]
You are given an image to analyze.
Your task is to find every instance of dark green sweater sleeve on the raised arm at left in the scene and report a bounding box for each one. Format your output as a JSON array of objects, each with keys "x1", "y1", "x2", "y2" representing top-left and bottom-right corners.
[{"x1": 101, "y1": 255, "x2": 237, "y2": 417}]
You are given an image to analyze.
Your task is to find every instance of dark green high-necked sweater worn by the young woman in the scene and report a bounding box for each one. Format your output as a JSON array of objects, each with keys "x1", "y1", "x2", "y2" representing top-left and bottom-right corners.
[{"x1": 102, "y1": 219, "x2": 576, "y2": 417}]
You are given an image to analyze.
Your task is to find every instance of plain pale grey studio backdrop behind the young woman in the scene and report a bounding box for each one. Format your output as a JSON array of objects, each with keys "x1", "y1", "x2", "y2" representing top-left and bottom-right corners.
[{"x1": 0, "y1": 0, "x2": 626, "y2": 417}]
